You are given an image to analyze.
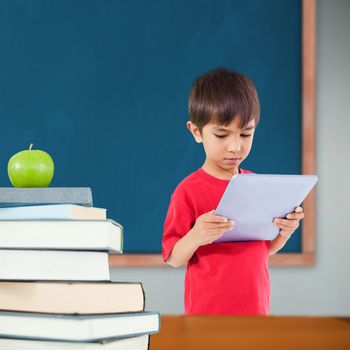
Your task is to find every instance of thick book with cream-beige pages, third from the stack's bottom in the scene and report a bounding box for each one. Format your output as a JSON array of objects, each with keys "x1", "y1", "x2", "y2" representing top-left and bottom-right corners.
[{"x1": 0, "y1": 281, "x2": 145, "y2": 314}]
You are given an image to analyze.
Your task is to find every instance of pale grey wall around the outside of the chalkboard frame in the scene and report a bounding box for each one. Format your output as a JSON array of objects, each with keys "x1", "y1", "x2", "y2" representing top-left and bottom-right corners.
[{"x1": 112, "y1": 0, "x2": 350, "y2": 316}]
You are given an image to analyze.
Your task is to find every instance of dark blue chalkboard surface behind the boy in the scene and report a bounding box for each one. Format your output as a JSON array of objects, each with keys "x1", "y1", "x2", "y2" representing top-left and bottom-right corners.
[{"x1": 0, "y1": 0, "x2": 301, "y2": 253}]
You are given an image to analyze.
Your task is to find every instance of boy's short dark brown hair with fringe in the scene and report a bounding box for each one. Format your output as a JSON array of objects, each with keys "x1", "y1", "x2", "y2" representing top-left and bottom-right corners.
[{"x1": 188, "y1": 68, "x2": 260, "y2": 132}]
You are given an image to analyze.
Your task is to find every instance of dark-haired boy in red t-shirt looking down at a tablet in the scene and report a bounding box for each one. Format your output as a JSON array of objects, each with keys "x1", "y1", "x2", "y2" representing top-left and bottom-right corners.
[{"x1": 162, "y1": 68, "x2": 304, "y2": 315}]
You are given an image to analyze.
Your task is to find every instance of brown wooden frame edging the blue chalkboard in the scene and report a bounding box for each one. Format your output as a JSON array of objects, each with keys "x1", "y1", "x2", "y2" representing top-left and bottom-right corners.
[{"x1": 109, "y1": 0, "x2": 316, "y2": 267}]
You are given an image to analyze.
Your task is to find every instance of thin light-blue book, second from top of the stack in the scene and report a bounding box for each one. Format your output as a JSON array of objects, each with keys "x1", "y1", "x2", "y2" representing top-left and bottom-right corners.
[{"x1": 0, "y1": 204, "x2": 107, "y2": 220}]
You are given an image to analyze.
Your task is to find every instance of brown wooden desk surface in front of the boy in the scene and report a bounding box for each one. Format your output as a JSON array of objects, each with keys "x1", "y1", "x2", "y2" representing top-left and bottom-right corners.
[{"x1": 150, "y1": 316, "x2": 350, "y2": 350}]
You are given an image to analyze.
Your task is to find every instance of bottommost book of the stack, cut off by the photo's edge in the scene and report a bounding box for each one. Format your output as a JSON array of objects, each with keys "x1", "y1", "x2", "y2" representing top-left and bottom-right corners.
[{"x1": 0, "y1": 335, "x2": 150, "y2": 350}]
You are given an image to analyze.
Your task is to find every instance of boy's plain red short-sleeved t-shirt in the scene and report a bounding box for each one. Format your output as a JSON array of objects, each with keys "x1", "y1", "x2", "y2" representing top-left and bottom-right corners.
[{"x1": 162, "y1": 169, "x2": 270, "y2": 315}]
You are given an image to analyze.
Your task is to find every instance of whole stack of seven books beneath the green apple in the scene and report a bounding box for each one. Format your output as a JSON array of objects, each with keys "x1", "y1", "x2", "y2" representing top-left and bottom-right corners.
[{"x1": 0, "y1": 188, "x2": 159, "y2": 350}]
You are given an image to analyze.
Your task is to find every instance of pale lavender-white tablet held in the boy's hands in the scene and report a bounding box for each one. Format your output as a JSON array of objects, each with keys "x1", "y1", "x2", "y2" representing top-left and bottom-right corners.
[{"x1": 215, "y1": 174, "x2": 318, "y2": 242}]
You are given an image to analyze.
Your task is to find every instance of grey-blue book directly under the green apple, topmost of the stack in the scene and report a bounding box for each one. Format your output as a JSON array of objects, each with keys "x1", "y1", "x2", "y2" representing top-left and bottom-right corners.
[{"x1": 0, "y1": 187, "x2": 93, "y2": 207}]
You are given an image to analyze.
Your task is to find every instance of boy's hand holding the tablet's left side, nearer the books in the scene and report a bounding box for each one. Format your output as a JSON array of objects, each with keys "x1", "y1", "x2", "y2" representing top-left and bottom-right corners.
[{"x1": 189, "y1": 210, "x2": 235, "y2": 246}]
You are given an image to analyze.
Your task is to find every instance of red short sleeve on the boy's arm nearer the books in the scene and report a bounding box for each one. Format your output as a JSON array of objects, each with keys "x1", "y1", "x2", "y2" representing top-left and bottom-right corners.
[{"x1": 162, "y1": 190, "x2": 195, "y2": 261}]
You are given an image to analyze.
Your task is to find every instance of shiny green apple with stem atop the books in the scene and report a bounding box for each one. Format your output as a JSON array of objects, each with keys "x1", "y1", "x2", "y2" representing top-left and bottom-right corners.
[{"x1": 7, "y1": 143, "x2": 54, "y2": 187}]
